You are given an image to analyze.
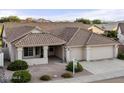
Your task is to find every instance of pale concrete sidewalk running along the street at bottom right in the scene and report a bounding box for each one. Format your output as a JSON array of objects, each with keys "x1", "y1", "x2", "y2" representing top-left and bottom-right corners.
[{"x1": 48, "y1": 70, "x2": 124, "y2": 83}]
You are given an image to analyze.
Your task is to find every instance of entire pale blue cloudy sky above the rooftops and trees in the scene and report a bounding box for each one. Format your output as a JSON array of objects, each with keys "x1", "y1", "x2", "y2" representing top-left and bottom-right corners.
[{"x1": 0, "y1": 9, "x2": 124, "y2": 21}]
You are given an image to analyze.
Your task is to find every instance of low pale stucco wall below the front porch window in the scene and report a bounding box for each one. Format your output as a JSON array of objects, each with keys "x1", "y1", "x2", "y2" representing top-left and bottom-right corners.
[{"x1": 22, "y1": 58, "x2": 48, "y2": 65}]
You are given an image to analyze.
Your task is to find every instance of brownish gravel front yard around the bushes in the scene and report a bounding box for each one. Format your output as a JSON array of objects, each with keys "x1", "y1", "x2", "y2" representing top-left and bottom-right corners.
[{"x1": 5, "y1": 63, "x2": 92, "y2": 83}]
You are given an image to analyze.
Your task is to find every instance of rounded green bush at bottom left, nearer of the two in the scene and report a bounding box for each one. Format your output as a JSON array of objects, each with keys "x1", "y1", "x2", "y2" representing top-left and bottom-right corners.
[{"x1": 11, "y1": 70, "x2": 31, "y2": 83}]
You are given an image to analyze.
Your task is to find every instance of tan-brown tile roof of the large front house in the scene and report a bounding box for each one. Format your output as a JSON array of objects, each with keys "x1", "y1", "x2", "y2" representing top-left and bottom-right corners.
[{"x1": 5, "y1": 23, "x2": 117, "y2": 47}]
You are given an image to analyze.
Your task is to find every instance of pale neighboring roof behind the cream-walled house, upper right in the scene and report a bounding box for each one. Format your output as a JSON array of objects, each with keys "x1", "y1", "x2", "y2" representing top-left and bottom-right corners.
[{"x1": 95, "y1": 23, "x2": 118, "y2": 31}]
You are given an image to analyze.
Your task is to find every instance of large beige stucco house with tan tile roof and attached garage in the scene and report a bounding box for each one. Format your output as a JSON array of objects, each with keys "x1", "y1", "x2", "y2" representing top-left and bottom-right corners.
[{"x1": 3, "y1": 22, "x2": 118, "y2": 65}]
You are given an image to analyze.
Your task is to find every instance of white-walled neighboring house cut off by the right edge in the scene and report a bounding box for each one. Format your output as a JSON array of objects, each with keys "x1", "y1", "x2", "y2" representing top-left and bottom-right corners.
[{"x1": 117, "y1": 23, "x2": 124, "y2": 45}]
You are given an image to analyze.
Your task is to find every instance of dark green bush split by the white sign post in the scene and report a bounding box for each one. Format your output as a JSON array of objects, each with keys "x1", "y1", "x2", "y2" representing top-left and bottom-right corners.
[{"x1": 66, "y1": 62, "x2": 83, "y2": 72}]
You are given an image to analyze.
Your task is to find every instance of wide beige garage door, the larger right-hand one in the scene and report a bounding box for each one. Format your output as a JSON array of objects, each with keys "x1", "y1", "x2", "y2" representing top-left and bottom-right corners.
[{"x1": 90, "y1": 46, "x2": 113, "y2": 60}]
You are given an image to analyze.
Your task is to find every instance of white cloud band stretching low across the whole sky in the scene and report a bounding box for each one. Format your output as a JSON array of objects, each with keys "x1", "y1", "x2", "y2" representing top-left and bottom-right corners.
[{"x1": 0, "y1": 9, "x2": 124, "y2": 21}]
